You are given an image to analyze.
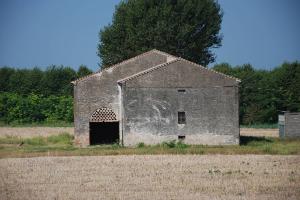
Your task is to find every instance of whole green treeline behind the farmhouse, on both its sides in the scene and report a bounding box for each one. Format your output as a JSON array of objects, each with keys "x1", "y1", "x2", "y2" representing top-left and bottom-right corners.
[{"x1": 0, "y1": 62, "x2": 300, "y2": 124}]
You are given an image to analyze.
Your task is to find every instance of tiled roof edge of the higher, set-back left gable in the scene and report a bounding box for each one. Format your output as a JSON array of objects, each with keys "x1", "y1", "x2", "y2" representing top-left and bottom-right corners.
[{"x1": 71, "y1": 49, "x2": 176, "y2": 85}]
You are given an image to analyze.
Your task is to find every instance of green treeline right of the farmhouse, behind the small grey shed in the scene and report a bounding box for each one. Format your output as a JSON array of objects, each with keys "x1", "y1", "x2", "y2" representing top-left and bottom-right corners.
[{"x1": 213, "y1": 62, "x2": 300, "y2": 124}]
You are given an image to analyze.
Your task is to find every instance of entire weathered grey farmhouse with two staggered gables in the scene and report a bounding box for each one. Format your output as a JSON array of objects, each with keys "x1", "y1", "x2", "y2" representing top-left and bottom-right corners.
[{"x1": 72, "y1": 50, "x2": 240, "y2": 146}]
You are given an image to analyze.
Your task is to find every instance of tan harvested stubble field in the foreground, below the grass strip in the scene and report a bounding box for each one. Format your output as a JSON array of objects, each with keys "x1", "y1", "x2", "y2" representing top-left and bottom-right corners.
[{"x1": 0, "y1": 155, "x2": 300, "y2": 200}]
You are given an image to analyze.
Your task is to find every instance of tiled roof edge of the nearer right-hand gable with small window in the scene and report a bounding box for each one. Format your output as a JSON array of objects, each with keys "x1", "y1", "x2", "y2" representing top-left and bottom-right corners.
[{"x1": 117, "y1": 57, "x2": 241, "y2": 84}]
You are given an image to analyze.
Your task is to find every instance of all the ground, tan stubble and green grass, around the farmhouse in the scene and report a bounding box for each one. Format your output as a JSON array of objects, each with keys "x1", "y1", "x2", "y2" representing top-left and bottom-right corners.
[{"x1": 0, "y1": 127, "x2": 300, "y2": 200}]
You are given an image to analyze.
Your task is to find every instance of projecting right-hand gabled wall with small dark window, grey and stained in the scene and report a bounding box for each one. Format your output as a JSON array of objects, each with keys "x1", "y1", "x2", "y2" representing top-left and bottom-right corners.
[{"x1": 122, "y1": 60, "x2": 239, "y2": 145}]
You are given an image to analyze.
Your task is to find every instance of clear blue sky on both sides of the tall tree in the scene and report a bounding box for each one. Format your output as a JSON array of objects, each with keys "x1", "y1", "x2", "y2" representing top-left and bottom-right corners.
[{"x1": 0, "y1": 0, "x2": 300, "y2": 70}]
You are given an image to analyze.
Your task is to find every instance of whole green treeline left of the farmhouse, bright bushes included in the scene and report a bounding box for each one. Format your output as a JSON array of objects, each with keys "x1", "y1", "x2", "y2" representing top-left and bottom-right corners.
[{"x1": 0, "y1": 65, "x2": 92, "y2": 124}]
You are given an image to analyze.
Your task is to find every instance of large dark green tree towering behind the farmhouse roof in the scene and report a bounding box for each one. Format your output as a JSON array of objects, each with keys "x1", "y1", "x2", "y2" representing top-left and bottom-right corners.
[{"x1": 98, "y1": 0, "x2": 222, "y2": 67}]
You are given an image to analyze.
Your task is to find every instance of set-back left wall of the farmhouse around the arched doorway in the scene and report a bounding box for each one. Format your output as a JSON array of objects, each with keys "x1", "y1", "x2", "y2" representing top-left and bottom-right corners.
[{"x1": 74, "y1": 51, "x2": 172, "y2": 146}]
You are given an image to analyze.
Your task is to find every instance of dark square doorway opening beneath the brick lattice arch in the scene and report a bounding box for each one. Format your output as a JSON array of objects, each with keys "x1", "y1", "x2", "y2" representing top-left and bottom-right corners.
[{"x1": 90, "y1": 122, "x2": 119, "y2": 145}]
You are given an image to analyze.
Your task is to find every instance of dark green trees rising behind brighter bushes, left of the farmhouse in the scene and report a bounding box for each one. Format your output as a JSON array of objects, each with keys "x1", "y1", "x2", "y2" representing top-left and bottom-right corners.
[{"x1": 0, "y1": 65, "x2": 92, "y2": 96}]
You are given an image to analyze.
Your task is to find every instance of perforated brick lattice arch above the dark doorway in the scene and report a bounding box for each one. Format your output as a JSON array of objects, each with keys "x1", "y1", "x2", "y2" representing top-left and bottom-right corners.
[{"x1": 90, "y1": 107, "x2": 117, "y2": 122}]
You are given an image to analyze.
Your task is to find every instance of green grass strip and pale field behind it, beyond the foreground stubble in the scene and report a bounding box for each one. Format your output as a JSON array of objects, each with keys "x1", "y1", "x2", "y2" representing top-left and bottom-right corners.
[{"x1": 0, "y1": 127, "x2": 300, "y2": 158}]
